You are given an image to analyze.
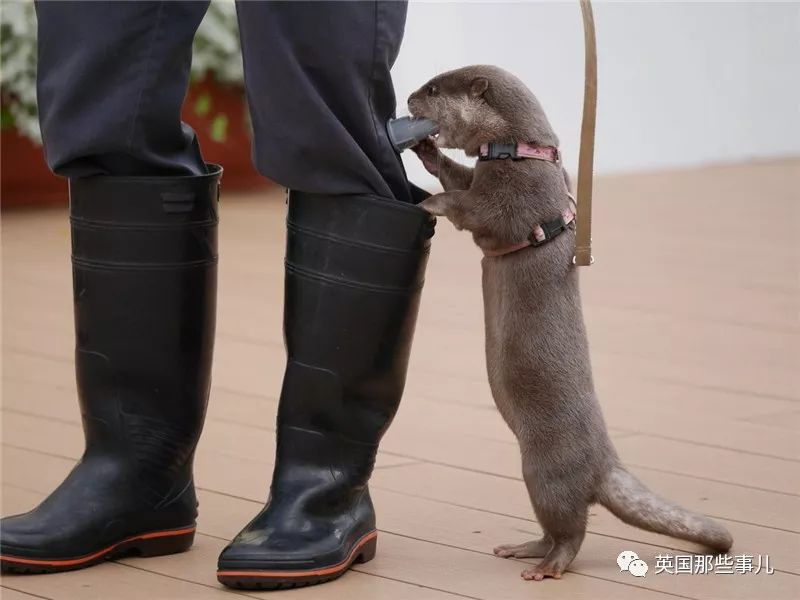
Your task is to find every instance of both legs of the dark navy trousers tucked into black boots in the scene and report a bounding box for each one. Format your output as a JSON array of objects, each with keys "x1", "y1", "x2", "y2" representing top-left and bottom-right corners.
[{"x1": 37, "y1": 0, "x2": 409, "y2": 201}]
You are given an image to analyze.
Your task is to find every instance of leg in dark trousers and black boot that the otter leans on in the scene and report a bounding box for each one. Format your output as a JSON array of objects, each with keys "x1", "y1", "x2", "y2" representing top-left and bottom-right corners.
[{"x1": 217, "y1": 2, "x2": 434, "y2": 589}]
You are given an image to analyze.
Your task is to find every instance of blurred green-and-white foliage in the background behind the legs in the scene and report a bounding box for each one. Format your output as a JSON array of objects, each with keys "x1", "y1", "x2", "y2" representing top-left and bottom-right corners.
[{"x1": 0, "y1": 0, "x2": 244, "y2": 143}]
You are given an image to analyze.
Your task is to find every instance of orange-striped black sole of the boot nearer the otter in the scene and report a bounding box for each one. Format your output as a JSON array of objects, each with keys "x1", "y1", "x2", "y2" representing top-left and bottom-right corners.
[{"x1": 217, "y1": 531, "x2": 378, "y2": 590}]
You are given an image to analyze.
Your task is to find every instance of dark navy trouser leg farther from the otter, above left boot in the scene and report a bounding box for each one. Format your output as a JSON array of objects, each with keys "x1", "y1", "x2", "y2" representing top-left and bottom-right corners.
[{"x1": 36, "y1": 0, "x2": 209, "y2": 177}]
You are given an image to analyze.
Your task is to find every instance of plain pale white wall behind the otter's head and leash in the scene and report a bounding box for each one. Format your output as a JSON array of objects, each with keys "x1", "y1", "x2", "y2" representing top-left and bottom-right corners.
[{"x1": 393, "y1": 0, "x2": 800, "y2": 185}]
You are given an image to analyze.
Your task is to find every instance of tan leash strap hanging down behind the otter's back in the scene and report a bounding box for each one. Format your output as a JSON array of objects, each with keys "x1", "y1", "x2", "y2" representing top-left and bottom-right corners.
[{"x1": 573, "y1": 0, "x2": 597, "y2": 267}]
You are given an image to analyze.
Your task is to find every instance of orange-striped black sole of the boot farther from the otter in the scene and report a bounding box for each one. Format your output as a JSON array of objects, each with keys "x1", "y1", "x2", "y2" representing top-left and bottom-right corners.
[{"x1": 0, "y1": 526, "x2": 195, "y2": 575}]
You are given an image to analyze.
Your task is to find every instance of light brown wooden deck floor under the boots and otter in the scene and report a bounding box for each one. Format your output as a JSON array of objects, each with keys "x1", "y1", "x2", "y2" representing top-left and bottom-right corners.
[{"x1": 0, "y1": 161, "x2": 800, "y2": 600}]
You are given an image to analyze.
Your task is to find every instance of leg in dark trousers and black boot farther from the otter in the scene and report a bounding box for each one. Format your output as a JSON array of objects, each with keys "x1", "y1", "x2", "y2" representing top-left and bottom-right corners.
[{"x1": 0, "y1": 2, "x2": 219, "y2": 573}]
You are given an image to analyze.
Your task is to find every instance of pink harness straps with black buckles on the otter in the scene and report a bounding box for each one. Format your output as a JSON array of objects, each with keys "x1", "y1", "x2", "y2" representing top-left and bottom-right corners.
[{"x1": 478, "y1": 142, "x2": 576, "y2": 257}]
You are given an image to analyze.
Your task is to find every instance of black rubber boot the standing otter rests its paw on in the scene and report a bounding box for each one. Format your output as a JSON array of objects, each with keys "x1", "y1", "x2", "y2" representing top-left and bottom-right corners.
[{"x1": 217, "y1": 192, "x2": 434, "y2": 589}]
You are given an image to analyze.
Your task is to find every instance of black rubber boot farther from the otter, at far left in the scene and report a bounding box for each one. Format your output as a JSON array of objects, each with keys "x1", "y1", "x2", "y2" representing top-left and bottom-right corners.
[{"x1": 0, "y1": 166, "x2": 221, "y2": 573}]
